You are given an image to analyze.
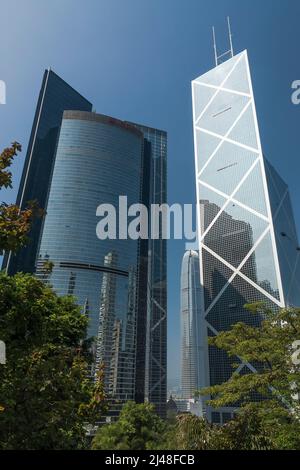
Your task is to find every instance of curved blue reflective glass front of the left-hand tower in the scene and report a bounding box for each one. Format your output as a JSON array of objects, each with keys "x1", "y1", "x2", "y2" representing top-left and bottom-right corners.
[{"x1": 37, "y1": 111, "x2": 143, "y2": 400}]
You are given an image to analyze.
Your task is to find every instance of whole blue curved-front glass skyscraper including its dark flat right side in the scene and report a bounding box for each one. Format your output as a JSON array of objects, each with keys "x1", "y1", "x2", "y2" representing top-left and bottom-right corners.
[{"x1": 37, "y1": 111, "x2": 166, "y2": 416}]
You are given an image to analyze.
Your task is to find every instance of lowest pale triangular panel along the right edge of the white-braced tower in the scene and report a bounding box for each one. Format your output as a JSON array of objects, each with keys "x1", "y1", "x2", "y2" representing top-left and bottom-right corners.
[{"x1": 234, "y1": 162, "x2": 268, "y2": 217}]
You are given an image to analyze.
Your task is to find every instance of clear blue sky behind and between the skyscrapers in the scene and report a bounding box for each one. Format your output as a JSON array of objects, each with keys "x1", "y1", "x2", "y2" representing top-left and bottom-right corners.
[{"x1": 0, "y1": 0, "x2": 300, "y2": 390}]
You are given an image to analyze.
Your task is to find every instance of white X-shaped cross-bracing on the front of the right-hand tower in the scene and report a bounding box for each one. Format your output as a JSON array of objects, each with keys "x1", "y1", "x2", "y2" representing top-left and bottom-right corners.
[{"x1": 192, "y1": 51, "x2": 285, "y2": 328}]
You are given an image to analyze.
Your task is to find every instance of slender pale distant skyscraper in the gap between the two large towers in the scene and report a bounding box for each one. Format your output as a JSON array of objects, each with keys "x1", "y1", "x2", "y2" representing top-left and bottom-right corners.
[{"x1": 180, "y1": 251, "x2": 203, "y2": 399}]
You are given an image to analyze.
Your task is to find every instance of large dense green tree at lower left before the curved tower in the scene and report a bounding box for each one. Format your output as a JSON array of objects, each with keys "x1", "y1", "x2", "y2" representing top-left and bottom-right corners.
[{"x1": 0, "y1": 273, "x2": 106, "y2": 449}]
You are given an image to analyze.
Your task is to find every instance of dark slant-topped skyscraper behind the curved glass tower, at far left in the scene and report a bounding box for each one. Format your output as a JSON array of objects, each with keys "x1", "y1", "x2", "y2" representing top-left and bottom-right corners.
[{"x1": 2, "y1": 69, "x2": 92, "y2": 275}]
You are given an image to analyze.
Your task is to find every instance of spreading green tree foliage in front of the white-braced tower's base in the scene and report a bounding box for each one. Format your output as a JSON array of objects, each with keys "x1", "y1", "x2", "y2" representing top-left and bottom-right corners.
[{"x1": 201, "y1": 304, "x2": 300, "y2": 417}]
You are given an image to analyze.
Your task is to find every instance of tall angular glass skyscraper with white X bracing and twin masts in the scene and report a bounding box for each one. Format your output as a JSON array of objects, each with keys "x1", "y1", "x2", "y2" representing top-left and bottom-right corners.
[{"x1": 192, "y1": 51, "x2": 300, "y2": 423}]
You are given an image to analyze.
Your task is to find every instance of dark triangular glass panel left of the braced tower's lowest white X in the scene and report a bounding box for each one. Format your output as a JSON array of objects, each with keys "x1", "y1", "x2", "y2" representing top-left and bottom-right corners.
[{"x1": 202, "y1": 249, "x2": 233, "y2": 310}]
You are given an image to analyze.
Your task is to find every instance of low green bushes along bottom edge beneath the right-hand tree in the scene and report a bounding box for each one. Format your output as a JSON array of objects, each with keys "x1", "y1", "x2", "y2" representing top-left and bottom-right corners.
[{"x1": 169, "y1": 403, "x2": 300, "y2": 450}]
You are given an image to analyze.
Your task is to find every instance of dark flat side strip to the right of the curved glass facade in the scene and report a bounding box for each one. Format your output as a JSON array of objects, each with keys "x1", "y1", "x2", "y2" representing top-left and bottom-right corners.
[{"x1": 127, "y1": 124, "x2": 167, "y2": 417}]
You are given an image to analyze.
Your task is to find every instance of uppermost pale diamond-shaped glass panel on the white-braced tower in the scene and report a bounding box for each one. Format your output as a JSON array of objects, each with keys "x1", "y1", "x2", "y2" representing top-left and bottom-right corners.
[{"x1": 197, "y1": 91, "x2": 250, "y2": 136}]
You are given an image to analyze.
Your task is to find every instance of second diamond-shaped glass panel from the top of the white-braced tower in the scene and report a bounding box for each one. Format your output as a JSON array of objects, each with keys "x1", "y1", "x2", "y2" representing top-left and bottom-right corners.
[{"x1": 200, "y1": 142, "x2": 258, "y2": 195}]
